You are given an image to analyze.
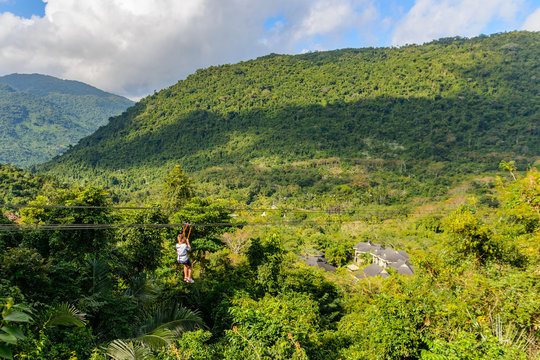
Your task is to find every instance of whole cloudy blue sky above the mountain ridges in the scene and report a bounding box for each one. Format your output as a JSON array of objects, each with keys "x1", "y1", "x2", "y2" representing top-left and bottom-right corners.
[{"x1": 0, "y1": 0, "x2": 540, "y2": 100}]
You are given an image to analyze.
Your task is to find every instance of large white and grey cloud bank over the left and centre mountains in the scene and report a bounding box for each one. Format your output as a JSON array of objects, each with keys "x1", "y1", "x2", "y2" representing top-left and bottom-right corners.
[{"x1": 0, "y1": 0, "x2": 375, "y2": 97}]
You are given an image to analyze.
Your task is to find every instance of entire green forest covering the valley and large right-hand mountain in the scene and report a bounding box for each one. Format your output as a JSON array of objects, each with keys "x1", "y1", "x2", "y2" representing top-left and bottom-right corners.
[{"x1": 0, "y1": 31, "x2": 540, "y2": 360}]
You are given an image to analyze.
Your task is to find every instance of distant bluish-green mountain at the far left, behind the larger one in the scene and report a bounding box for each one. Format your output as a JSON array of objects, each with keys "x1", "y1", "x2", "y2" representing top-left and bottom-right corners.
[{"x1": 0, "y1": 74, "x2": 133, "y2": 166}]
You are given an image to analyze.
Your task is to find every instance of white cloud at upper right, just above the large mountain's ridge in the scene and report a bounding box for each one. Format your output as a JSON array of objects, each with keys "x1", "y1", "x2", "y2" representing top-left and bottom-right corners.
[{"x1": 392, "y1": 0, "x2": 523, "y2": 45}]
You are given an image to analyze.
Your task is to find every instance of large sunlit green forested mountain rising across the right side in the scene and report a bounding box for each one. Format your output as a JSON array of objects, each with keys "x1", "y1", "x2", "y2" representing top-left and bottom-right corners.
[{"x1": 39, "y1": 32, "x2": 540, "y2": 198}]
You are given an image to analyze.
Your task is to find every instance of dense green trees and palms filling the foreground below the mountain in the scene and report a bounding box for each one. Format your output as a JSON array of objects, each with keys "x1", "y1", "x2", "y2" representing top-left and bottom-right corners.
[{"x1": 0, "y1": 169, "x2": 540, "y2": 360}]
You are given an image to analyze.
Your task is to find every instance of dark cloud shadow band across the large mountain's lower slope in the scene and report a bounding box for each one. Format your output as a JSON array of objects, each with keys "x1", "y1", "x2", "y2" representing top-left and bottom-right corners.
[{"x1": 43, "y1": 96, "x2": 540, "y2": 177}]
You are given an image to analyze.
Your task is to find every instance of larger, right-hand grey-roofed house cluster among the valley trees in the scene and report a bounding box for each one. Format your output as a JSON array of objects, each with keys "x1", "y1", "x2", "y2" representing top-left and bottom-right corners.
[{"x1": 354, "y1": 241, "x2": 414, "y2": 278}]
